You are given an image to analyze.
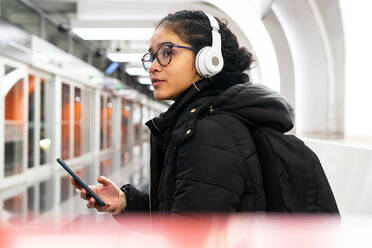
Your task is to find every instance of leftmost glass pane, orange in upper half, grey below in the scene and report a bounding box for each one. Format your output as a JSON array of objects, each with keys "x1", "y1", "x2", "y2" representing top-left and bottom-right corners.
[{"x1": 4, "y1": 79, "x2": 24, "y2": 177}]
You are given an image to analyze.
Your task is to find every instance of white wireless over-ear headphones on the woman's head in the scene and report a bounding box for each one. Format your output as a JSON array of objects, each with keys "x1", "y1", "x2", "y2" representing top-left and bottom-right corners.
[{"x1": 195, "y1": 12, "x2": 223, "y2": 78}]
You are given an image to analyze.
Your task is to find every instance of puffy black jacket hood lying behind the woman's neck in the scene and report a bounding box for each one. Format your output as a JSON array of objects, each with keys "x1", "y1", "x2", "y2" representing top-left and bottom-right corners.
[{"x1": 212, "y1": 79, "x2": 294, "y2": 133}]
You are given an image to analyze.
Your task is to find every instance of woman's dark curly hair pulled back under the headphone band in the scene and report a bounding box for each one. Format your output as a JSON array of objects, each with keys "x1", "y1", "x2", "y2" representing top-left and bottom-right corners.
[{"x1": 156, "y1": 10, "x2": 253, "y2": 74}]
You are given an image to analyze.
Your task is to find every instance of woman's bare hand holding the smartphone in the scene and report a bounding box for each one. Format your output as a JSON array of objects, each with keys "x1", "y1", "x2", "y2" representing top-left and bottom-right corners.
[{"x1": 71, "y1": 176, "x2": 120, "y2": 213}]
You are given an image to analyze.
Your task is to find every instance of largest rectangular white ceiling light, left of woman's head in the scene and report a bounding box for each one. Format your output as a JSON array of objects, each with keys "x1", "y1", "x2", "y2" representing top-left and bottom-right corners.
[{"x1": 72, "y1": 27, "x2": 154, "y2": 40}]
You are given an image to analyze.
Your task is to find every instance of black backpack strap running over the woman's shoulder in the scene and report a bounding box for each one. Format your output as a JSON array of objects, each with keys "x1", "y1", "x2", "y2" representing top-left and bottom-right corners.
[{"x1": 215, "y1": 111, "x2": 287, "y2": 212}]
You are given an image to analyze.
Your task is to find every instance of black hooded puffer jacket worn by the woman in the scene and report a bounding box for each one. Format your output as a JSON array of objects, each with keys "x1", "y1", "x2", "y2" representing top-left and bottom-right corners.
[{"x1": 121, "y1": 73, "x2": 294, "y2": 212}]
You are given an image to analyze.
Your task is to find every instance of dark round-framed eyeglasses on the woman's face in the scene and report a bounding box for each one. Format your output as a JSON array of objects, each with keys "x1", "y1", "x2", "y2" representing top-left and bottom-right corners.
[{"x1": 142, "y1": 43, "x2": 197, "y2": 72}]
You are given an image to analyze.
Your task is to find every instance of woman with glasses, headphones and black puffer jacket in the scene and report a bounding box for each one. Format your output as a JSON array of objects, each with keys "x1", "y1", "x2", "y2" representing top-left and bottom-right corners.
[{"x1": 72, "y1": 11, "x2": 293, "y2": 215}]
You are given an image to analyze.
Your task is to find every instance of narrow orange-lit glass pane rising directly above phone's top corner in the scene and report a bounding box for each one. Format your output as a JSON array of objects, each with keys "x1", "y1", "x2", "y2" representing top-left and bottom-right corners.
[{"x1": 61, "y1": 83, "x2": 70, "y2": 159}]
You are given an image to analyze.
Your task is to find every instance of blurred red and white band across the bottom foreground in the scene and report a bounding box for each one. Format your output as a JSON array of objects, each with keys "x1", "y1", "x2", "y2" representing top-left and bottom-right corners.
[{"x1": 0, "y1": 215, "x2": 372, "y2": 248}]
